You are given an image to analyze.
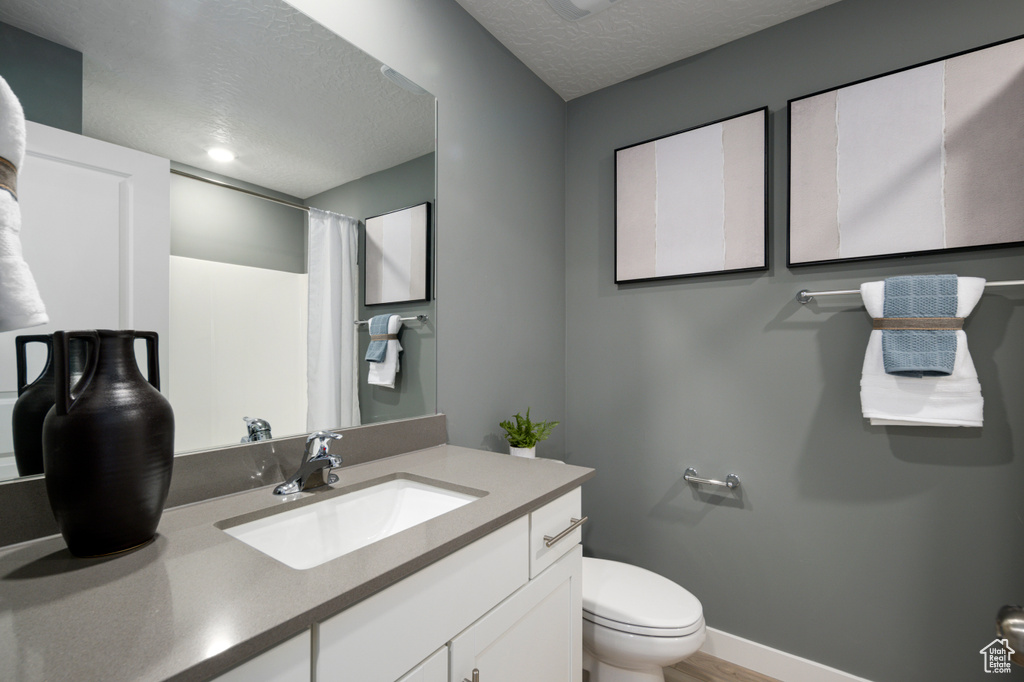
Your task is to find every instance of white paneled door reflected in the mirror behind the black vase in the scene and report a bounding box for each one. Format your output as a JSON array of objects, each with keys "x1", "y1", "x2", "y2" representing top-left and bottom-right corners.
[{"x1": 0, "y1": 121, "x2": 171, "y2": 458}]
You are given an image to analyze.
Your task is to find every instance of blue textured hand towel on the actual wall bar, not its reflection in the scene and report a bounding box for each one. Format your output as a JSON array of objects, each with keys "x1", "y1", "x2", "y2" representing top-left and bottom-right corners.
[{"x1": 882, "y1": 274, "x2": 957, "y2": 378}]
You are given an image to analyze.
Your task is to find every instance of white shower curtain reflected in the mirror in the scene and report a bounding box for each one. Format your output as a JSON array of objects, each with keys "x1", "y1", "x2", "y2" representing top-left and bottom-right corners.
[{"x1": 306, "y1": 208, "x2": 359, "y2": 431}]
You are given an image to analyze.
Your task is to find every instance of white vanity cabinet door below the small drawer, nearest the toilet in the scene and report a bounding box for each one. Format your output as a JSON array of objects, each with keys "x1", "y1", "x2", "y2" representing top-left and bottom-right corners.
[{"x1": 450, "y1": 545, "x2": 583, "y2": 682}]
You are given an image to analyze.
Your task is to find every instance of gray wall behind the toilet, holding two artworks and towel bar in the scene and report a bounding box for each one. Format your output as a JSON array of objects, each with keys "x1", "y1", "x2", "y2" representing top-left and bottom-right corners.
[{"x1": 565, "y1": 0, "x2": 1024, "y2": 682}]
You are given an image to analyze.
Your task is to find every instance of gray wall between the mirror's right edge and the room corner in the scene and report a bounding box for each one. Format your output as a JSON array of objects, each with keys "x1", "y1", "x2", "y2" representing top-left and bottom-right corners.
[{"x1": 289, "y1": 0, "x2": 565, "y2": 456}]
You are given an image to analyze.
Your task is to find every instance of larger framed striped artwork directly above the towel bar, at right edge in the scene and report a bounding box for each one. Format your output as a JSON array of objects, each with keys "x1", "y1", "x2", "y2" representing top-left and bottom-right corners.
[{"x1": 788, "y1": 34, "x2": 1024, "y2": 265}]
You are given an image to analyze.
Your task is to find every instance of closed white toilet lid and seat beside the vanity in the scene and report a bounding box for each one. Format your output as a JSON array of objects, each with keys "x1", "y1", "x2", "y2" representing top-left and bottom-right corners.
[{"x1": 583, "y1": 557, "x2": 703, "y2": 637}]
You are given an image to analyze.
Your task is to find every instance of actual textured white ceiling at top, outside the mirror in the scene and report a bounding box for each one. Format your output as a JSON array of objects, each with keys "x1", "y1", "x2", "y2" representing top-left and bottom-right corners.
[{"x1": 457, "y1": 0, "x2": 838, "y2": 100}]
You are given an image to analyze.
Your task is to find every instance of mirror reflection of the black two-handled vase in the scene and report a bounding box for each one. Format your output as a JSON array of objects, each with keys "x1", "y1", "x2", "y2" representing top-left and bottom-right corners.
[{"x1": 11, "y1": 334, "x2": 85, "y2": 476}]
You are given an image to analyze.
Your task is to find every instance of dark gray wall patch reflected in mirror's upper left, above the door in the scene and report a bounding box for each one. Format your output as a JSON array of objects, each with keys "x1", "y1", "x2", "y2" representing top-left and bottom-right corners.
[{"x1": 0, "y1": 22, "x2": 82, "y2": 134}]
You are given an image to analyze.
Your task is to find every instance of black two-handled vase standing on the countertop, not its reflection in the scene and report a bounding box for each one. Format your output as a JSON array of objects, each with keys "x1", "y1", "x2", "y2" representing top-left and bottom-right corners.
[{"x1": 43, "y1": 330, "x2": 174, "y2": 556}]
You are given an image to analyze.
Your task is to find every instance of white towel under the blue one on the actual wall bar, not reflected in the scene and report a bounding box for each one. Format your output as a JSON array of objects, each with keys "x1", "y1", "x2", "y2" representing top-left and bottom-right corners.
[{"x1": 860, "y1": 278, "x2": 985, "y2": 426}]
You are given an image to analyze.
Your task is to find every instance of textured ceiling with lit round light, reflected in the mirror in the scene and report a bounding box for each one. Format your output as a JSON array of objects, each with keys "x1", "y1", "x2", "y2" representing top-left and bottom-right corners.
[{"x1": 0, "y1": 0, "x2": 434, "y2": 198}]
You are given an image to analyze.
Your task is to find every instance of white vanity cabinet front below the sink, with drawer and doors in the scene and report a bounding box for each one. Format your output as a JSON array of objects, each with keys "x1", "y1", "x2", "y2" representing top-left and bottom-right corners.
[{"x1": 313, "y1": 488, "x2": 583, "y2": 682}]
